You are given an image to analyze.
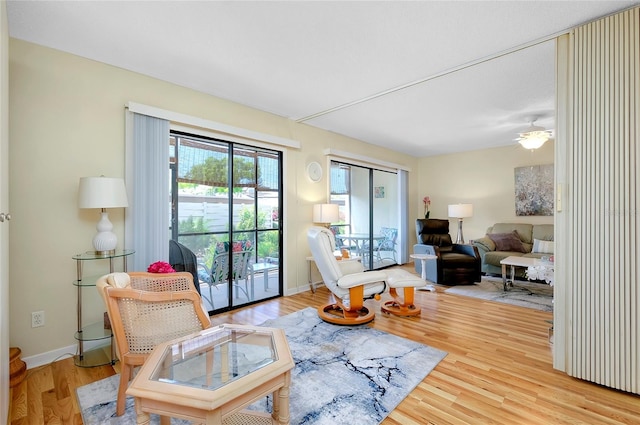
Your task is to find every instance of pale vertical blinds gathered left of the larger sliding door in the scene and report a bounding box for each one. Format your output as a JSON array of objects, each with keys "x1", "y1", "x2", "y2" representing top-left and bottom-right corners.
[{"x1": 125, "y1": 110, "x2": 170, "y2": 271}]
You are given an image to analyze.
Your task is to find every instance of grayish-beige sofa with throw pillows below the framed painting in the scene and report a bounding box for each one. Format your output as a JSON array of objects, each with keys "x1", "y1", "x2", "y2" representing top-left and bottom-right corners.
[{"x1": 472, "y1": 223, "x2": 554, "y2": 278}]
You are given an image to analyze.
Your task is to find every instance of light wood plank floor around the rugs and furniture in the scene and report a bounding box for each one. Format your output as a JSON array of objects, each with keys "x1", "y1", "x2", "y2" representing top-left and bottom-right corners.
[{"x1": 11, "y1": 269, "x2": 640, "y2": 425}]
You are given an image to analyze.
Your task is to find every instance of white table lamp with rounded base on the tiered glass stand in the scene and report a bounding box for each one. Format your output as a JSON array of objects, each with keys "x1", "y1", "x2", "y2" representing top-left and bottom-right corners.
[{"x1": 78, "y1": 176, "x2": 129, "y2": 255}]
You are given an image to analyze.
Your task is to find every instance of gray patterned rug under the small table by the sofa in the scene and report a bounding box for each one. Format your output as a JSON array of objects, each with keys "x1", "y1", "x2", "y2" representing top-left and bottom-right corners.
[{"x1": 444, "y1": 276, "x2": 553, "y2": 311}]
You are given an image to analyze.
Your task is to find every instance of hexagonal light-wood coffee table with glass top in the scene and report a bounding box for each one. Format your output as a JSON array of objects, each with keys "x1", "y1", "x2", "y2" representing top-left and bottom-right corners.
[{"x1": 127, "y1": 324, "x2": 294, "y2": 425}]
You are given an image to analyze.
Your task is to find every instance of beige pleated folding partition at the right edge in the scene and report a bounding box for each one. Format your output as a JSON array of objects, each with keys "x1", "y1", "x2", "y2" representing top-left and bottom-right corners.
[{"x1": 554, "y1": 8, "x2": 640, "y2": 393}]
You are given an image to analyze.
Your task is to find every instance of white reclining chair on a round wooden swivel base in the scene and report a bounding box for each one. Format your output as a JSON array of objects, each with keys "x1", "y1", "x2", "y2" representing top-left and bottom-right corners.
[{"x1": 307, "y1": 226, "x2": 387, "y2": 325}]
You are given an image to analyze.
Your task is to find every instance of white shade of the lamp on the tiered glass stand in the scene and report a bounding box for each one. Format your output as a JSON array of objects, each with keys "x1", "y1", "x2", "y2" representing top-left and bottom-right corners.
[{"x1": 78, "y1": 176, "x2": 129, "y2": 208}]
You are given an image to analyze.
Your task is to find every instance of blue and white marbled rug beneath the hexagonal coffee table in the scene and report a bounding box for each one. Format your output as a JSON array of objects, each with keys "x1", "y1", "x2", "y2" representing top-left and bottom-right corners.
[{"x1": 77, "y1": 308, "x2": 447, "y2": 425}]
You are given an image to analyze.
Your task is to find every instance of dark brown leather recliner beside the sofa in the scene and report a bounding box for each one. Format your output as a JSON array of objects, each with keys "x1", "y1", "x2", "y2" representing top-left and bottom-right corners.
[{"x1": 413, "y1": 218, "x2": 482, "y2": 285}]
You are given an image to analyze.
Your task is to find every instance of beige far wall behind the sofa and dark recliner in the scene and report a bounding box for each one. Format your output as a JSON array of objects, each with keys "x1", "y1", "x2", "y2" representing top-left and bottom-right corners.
[{"x1": 412, "y1": 142, "x2": 554, "y2": 241}]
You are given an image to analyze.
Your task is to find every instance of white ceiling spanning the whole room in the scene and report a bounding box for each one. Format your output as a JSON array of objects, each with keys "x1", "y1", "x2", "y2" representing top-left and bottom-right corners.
[{"x1": 7, "y1": 0, "x2": 640, "y2": 157}]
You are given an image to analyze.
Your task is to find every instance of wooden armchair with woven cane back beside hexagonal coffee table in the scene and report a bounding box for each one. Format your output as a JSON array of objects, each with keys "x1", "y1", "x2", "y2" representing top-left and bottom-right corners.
[{"x1": 96, "y1": 272, "x2": 211, "y2": 416}]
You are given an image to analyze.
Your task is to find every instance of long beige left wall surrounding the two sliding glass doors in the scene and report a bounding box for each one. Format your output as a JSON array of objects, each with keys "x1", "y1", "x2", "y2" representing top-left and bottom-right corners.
[{"x1": 9, "y1": 39, "x2": 417, "y2": 358}]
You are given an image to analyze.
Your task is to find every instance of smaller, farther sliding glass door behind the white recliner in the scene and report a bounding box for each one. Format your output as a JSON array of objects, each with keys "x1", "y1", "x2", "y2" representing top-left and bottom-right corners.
[{"x1": 330, "y1": 161, "x2": 399, "y2": 270}]
